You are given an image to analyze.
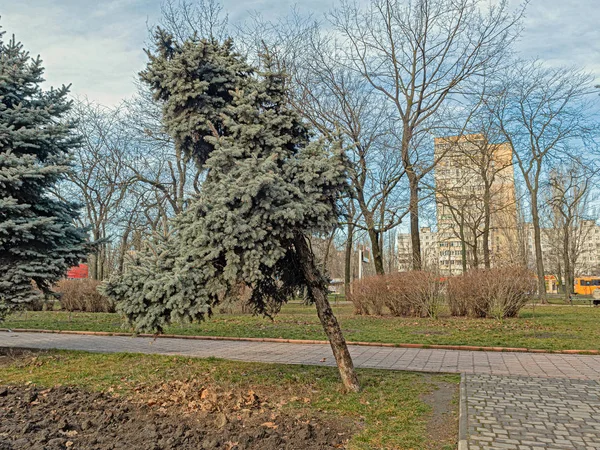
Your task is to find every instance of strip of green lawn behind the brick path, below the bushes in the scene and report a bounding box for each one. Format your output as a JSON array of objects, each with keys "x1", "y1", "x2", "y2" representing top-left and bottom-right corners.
[{"x1": 0, "y1": 303, "x2": 600, "y2": 350}]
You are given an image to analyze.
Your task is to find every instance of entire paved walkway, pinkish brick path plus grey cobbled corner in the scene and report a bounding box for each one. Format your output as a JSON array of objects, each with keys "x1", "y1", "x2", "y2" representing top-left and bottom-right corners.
[{"x1": 0, "y1": 332, "x2": 600, "y2": 450}]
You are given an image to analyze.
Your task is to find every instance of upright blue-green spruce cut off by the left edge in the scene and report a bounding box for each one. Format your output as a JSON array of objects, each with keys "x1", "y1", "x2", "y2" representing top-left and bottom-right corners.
[{"x1": 0, "y1": 29, "x2": 87, "y2": 319}]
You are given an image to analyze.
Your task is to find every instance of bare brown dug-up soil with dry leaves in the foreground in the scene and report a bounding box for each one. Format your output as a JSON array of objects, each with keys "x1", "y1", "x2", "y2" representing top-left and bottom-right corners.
[{"x1": 0, "y1": 385, "x2": 352, "y2": 450}]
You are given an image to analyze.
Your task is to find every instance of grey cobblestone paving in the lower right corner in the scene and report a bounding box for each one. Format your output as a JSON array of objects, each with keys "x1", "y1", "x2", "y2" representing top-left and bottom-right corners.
[{"x1": 466, "y1": 375, "x2": 600, "y2": 450}]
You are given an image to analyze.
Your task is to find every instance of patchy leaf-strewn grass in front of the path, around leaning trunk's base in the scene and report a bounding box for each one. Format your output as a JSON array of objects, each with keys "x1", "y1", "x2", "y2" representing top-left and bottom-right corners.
[{"x1": 0, "y1": 351, "x2": 459, "y2": 450}]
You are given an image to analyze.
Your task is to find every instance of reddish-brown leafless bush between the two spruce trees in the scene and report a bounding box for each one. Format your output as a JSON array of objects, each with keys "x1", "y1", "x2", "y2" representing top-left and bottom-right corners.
[{"x1": 54, "y1": 279, "x2": 115, "y2": 312}]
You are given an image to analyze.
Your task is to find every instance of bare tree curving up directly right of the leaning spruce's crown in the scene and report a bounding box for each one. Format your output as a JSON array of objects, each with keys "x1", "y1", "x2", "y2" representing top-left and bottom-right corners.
[{"x1": 241, "y1": 11, "x2": 407, "y2": 274}]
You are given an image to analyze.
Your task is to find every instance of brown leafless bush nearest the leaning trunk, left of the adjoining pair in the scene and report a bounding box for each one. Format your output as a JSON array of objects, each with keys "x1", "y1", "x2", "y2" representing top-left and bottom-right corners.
[{"x1": 350, "y1": 271, "x2": 443, "y2": 317}]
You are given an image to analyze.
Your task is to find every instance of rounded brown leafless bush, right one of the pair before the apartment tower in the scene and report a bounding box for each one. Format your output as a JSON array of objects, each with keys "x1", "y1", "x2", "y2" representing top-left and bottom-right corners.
[{"x1": 448, "y1": 267, "x2": 537, "y2": 319}]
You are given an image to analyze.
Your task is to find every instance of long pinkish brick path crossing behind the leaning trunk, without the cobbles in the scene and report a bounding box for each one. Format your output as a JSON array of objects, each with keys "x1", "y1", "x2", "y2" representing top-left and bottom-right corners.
[{"x1": 0, "y1": 332, "x2": 600, "y2": 379}]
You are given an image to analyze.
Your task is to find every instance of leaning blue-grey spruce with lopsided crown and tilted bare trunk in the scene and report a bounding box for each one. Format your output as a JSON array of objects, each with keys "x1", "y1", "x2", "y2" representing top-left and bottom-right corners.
[{"x1": 104, "y1": 31, "x2": 359, "y2": 391}]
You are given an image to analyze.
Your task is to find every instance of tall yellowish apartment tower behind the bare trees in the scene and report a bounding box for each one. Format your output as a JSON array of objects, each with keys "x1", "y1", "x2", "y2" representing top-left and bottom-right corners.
[{"x1": 398, "y1": 134, "x2": 518, "y2": 275}]
